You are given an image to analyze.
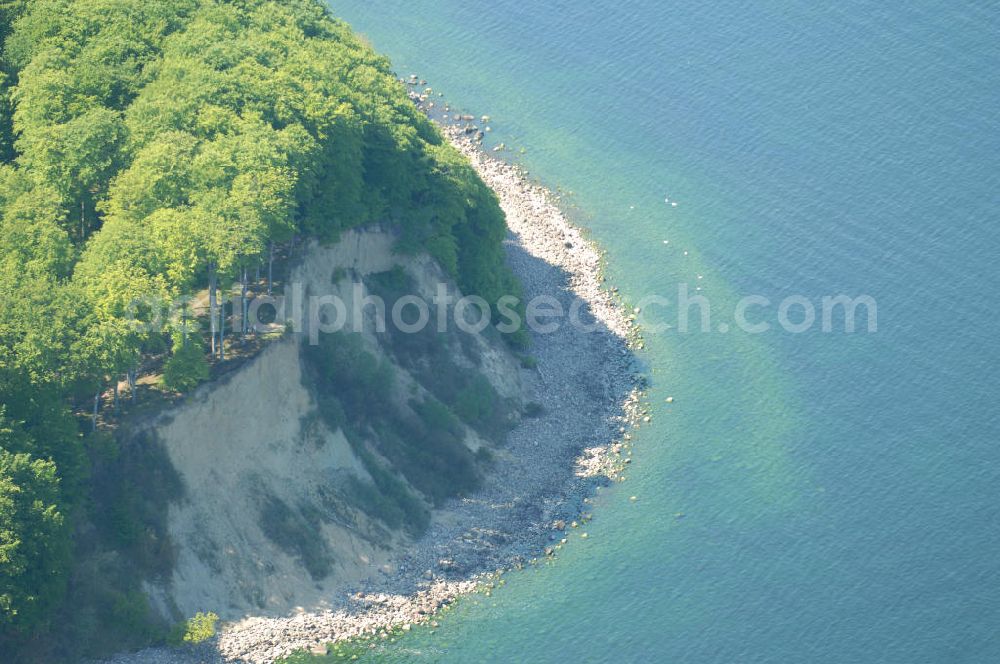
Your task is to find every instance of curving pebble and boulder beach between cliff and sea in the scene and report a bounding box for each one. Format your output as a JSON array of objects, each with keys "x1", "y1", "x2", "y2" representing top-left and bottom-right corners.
[{"x1": 108, "y1": 102, "x2": 645, "y2": 664}]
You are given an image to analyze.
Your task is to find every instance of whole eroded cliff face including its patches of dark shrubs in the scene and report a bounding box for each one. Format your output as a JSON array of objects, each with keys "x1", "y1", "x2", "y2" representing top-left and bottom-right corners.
[{"x1": 134, "y1": 230, "x2": 522, "y2": 619}]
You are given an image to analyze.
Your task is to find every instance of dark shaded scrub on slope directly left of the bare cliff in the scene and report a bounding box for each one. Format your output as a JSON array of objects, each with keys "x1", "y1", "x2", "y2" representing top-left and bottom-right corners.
[{"x1": 30, "y1": 432, "x2": 181, "y2": 662}]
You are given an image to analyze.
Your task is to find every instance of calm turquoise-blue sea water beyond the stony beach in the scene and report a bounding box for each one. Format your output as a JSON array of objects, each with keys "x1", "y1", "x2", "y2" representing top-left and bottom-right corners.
[{"x1": 332, "y1": 0, "x2": 1000, "y2": 664}]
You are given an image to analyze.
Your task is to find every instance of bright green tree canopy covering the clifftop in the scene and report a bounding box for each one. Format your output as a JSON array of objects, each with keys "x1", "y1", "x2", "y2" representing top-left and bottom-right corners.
[{"x1": 0, "y1": 0, "x2": 516, "y2": 644}]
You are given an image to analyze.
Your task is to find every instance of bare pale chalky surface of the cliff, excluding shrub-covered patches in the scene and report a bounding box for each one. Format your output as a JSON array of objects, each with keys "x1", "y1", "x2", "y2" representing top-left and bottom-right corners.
[{"x1": 144, "y1": 230, "x2": 522, "y2": 618}]
